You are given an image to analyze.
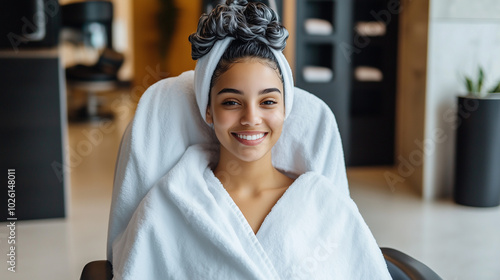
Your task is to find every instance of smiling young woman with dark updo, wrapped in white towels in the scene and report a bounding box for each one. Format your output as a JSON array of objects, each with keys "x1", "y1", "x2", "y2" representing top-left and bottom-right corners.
[{"x1": 108, "y1": 0, "x2": 390, "y2": 279}]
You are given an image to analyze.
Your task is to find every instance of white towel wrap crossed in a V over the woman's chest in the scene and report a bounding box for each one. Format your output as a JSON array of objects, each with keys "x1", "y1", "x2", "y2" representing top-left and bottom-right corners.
[{"x1": 113, "y1": 144, "x2": 391, "y2": 280}]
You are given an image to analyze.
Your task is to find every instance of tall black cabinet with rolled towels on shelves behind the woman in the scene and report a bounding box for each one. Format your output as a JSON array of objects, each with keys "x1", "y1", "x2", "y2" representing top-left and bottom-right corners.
[{"x1": 295, "y1": 0, "x2": 399, "y2": 166}]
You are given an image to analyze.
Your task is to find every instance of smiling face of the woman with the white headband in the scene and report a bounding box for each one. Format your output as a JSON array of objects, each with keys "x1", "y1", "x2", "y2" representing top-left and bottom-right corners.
[{"x1": 206, "y1": 58, "x2": 285, "y2": 162}]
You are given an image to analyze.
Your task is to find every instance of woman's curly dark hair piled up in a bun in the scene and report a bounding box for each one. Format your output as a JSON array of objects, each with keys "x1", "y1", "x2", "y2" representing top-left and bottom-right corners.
[{"x1": 189, "y1": 0, "x2": 288, "y2": 98}]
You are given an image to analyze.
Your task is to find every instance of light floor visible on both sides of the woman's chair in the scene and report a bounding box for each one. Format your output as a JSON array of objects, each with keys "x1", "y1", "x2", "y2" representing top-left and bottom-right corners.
[{"x1": 0, "y1": 93, "x2": 500, "y2": 280}]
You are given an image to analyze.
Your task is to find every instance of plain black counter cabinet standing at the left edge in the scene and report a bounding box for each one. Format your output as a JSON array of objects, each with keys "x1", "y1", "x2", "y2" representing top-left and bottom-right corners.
[{"x1": 0, "y1": 53, "x2": 67, "y2": 221}]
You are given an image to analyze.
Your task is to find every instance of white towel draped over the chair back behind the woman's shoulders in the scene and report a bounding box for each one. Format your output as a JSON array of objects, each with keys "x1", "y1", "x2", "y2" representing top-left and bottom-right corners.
[{"x1": 107, "y1": 71, "x2": 349, "y2": 261}]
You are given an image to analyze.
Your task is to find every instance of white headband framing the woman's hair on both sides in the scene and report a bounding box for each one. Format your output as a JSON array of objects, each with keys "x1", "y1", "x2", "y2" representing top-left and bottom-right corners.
[{"x1": 194, "y1": 37, "x2": 294, "y2": 120}]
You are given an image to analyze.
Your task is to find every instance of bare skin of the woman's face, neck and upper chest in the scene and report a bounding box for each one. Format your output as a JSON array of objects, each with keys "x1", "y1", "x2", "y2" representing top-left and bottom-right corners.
[{"x1": 206, "y1": 58, "x2": 293, "y2": 233}]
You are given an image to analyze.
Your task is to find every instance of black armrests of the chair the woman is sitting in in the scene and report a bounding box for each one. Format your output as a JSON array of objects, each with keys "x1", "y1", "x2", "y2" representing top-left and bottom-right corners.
[{"x1": 80, "y1": 248, "x2": 441, "y2": 280}]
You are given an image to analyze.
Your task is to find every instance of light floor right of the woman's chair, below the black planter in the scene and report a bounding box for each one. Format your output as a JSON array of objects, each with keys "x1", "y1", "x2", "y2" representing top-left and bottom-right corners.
[{"x1": 348, "y1": 168, "x2": 500, "y2": 280}]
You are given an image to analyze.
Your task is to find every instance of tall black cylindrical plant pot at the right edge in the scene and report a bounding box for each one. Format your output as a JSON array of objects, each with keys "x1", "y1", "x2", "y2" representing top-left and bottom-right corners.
[{"x1": 454, "y1": 97, "x2": 500, "y2": 207}]
